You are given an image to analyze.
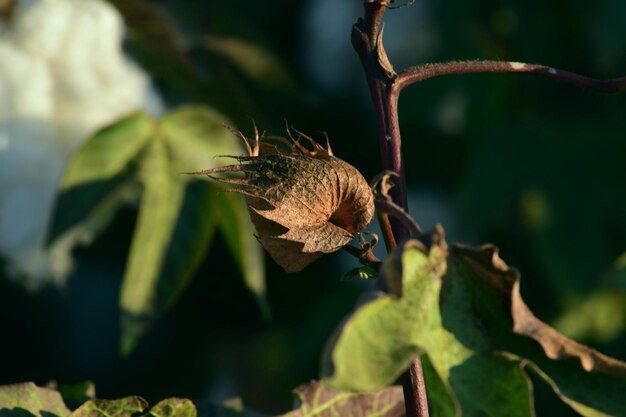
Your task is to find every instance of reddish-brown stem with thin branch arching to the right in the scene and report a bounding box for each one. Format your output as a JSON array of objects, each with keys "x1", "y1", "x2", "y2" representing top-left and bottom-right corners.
[{"x1": 352, "y1": 0, "x2": 626, "y2": 417}]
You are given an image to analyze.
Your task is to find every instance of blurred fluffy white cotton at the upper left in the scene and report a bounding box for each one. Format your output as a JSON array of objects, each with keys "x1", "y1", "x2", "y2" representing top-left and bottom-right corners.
[{"x1": 0, "y1": 0, "x2": 162, "y2": 287}]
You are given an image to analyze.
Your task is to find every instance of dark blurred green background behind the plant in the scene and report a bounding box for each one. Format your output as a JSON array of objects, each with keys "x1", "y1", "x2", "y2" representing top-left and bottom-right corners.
[{"x1": 0, "y1": 0, "x2": 626, "y2": 415}]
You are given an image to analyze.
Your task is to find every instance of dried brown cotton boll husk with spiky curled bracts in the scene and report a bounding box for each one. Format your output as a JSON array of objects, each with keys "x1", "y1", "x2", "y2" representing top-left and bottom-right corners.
[{"x1": 195, "y1": 128, "x2": 374, "y2": 272}]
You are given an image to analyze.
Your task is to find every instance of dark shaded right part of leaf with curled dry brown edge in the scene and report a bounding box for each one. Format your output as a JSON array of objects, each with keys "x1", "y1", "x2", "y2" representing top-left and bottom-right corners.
[{"x1": 444, "y1": 245, "x2": 626, "y2": 416}]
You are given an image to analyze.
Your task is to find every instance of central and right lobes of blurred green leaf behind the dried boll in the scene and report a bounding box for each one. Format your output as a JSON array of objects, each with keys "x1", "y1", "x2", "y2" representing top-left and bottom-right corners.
[{"x1": 120, "y1": 106, "x2": 251, "y2": 354}]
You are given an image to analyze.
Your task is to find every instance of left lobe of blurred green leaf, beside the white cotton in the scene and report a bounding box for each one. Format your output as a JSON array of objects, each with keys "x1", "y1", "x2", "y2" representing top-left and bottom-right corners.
[{"x1": 48, "y1": 113, "x2": 154, "y2": 250}]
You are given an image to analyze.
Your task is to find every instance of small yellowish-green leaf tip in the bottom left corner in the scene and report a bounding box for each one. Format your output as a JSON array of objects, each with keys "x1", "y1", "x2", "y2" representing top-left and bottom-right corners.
[{"x1": 0, "y1": 382, "x2": 70, "y2": 417}]
